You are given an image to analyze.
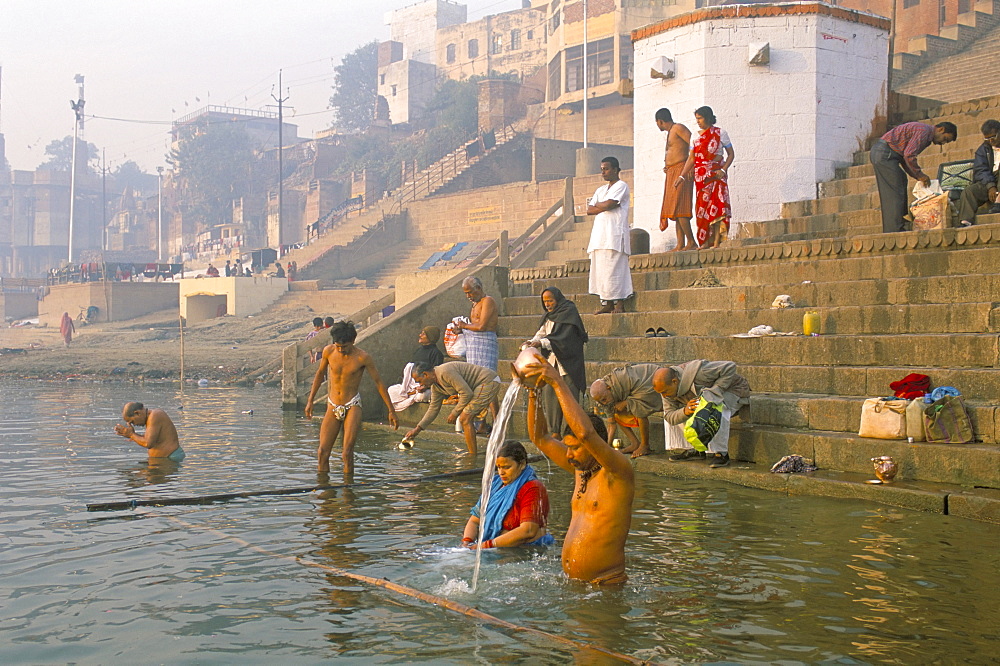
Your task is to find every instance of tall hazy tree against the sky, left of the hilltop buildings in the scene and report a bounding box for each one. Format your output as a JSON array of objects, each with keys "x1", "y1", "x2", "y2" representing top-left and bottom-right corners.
[{"x1": 330, "y1": 42, "x2": 378, "y2": 132}]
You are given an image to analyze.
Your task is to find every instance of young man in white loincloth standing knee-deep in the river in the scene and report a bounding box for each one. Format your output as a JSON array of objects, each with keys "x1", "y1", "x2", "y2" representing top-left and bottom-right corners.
[{"x1": 306, "y1": 321, "x2": 399, "y2": 470}]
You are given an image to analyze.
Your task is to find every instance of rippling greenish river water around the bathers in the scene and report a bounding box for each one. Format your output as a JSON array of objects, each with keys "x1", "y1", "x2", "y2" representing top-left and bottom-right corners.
[{"x1": 0, "y1": 382, "x2": 1000, "y2": 664}]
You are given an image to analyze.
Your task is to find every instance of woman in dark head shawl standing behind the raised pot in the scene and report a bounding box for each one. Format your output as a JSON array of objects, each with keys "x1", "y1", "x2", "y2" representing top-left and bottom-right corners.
[{"x1": 522, "y1": 287, "x2": 587, "y2": 437}]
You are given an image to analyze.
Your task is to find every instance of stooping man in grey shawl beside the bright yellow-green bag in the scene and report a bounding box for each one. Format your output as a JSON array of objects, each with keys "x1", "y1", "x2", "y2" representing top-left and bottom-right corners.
[{"x1": 653, "y1": 361, "x2": 750, "y2": 468}]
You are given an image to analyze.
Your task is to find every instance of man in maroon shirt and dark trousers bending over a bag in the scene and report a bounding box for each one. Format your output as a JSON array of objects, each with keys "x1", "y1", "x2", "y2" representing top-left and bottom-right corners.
[{"x1": 869, "y1": 122, "x2": 958, "y2": 233}]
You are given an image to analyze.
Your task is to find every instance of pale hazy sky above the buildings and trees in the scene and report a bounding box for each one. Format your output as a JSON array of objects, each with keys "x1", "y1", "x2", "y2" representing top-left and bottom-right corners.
[{"x1": 0, "y1": 0, "x2": 521, "y2": 171}]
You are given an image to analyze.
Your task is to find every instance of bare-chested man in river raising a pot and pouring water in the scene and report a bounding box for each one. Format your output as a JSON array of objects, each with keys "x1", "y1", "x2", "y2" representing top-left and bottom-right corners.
[{"x1": 523, "y1": 363, "x2": 635, "y2": 585}]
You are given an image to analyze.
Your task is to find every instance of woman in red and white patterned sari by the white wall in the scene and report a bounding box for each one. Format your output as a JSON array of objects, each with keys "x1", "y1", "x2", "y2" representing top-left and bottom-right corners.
[{"x1": 674, "y1": 106, "x2": 736, "y2": 247}]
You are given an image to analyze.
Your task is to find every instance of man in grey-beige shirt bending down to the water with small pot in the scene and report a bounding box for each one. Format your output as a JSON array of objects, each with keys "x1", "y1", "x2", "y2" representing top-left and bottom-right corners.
[{"x1": 405, "y1": 361, "x2": 500, "y2": 456}]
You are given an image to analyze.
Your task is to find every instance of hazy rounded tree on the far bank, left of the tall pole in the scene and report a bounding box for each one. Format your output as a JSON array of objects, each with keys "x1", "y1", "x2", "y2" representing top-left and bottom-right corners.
[{"x1": 167, "y1": 121, "x2": 255, "y2": 228}]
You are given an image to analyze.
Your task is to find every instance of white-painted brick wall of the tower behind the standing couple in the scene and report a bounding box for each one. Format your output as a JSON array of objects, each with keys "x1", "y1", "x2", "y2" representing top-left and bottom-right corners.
[{"x1": 632, "y1": 5, "x2": 888, "y2": 252}]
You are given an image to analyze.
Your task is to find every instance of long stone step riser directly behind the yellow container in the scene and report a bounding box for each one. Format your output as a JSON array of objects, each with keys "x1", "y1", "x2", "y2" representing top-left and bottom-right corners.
[{"x1": 500, "y1": 297, "x2": 1000, "y2": 339}]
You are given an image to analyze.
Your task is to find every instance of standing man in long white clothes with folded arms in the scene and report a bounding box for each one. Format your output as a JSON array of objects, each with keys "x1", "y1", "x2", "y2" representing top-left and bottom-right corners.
[{"x1": 587, "y1": 157, "x2": 632, "y2": 314}]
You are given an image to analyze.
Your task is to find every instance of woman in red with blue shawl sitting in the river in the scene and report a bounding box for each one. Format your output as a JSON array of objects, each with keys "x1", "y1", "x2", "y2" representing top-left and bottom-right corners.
[{"x1": 462, "y1": 440, "x2": 555, "y2": 549}]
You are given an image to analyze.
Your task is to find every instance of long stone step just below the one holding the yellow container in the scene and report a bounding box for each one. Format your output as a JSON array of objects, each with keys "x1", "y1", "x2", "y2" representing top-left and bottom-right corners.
[{"x1": 500, "y1": 327, "x2": 1000, "y2": 370}]
